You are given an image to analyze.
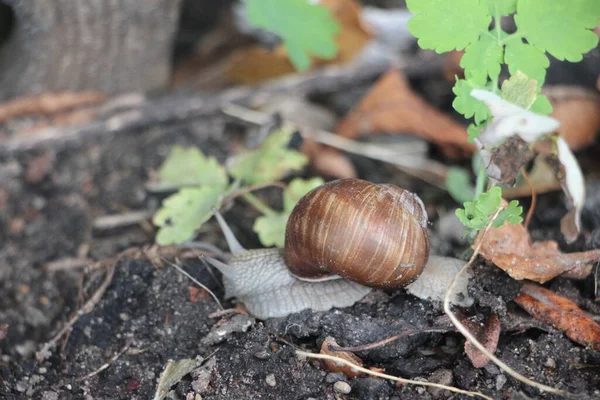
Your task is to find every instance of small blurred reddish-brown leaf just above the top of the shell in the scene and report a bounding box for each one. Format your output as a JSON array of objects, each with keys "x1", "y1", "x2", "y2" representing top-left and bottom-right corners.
[{"x1": 302, "y1": 139, "x2": 357, "y2": 178}]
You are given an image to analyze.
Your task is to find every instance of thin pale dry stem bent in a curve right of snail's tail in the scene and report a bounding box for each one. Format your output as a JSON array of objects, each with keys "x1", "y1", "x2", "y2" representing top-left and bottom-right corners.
[{"x1": 444, "y1": 207, "x2": 587, "y2": 399}]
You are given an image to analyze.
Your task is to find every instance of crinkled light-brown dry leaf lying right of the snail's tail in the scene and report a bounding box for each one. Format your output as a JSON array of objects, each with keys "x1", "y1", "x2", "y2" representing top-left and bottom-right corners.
[{"x1": 477, "y1": 220, "x2": 600, "y2": 283}]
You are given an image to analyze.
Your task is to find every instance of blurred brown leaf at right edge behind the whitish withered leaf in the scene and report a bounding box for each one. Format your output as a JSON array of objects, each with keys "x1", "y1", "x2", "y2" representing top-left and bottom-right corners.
[{"x1": 543, "y1": 86, "x2": 600, "y2": 151}]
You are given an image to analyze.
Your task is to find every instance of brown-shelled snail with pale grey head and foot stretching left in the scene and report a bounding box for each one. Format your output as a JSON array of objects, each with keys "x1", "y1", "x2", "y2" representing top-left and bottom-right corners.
[{"x1": 206, "y1": 179, "x2": 429, "y2": 319}]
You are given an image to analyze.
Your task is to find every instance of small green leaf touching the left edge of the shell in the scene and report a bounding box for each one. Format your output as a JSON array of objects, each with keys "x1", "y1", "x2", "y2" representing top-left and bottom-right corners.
[{"x1": 253, "y1": 177, "x2": 324, "y2": 247}]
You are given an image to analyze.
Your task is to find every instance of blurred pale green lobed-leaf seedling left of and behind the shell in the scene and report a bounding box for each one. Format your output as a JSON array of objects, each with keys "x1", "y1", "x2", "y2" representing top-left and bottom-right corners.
[{"x1": 153, "y1": 129, "x2": 323, "y2": 247}]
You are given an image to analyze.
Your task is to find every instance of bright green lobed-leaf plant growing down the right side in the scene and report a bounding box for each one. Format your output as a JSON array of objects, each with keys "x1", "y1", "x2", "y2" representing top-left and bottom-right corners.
[{"x1": 407, "y1": 0, "x2": 600, "y2": 230}]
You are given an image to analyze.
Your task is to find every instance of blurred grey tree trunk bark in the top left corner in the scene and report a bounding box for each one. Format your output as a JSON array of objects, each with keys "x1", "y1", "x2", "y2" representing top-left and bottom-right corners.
[{"x1": 0, "y1": 0, "x2": 181, "y2": 100}]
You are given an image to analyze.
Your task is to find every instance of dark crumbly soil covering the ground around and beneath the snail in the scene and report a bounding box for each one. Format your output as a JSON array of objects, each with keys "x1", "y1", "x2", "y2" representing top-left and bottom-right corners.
[{"x1": 0, "y1": 70, "x2": 600, "y2": 400}]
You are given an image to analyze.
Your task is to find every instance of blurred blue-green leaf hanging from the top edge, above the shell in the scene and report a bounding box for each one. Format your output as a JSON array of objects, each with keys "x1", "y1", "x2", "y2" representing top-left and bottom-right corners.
[{"x1": 245, "y1": 0, "x2": 340, "y2": 71}]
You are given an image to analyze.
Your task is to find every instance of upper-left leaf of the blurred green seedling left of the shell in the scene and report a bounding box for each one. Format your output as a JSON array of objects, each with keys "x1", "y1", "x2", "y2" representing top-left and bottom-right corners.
[{"x1": 158, "y1": 145, "x2": 228, "y2": 187}]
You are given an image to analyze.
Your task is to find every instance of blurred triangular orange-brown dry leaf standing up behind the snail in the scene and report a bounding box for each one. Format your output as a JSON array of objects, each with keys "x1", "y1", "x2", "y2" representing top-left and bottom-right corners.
[{"x1": 336, "y1": 70, "x2": 475, "y2": 157}]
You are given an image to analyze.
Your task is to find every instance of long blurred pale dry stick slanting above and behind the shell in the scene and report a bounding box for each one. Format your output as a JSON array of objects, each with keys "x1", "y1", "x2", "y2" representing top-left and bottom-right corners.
[{"x1": 221, "y1": 103, "x2": 448, "y2": 190}]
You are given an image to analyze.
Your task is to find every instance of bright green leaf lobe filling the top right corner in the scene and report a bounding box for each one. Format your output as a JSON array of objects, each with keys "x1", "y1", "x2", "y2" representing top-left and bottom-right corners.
[{"x1": 515, "y1": 0, "x2": 600, "y2": 62}]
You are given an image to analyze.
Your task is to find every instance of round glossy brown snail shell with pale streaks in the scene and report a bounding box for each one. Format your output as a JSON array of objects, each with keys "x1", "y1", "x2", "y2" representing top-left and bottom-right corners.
[{"x1": 284, "y1": 179, "x2": 429, "y2": 288}]
